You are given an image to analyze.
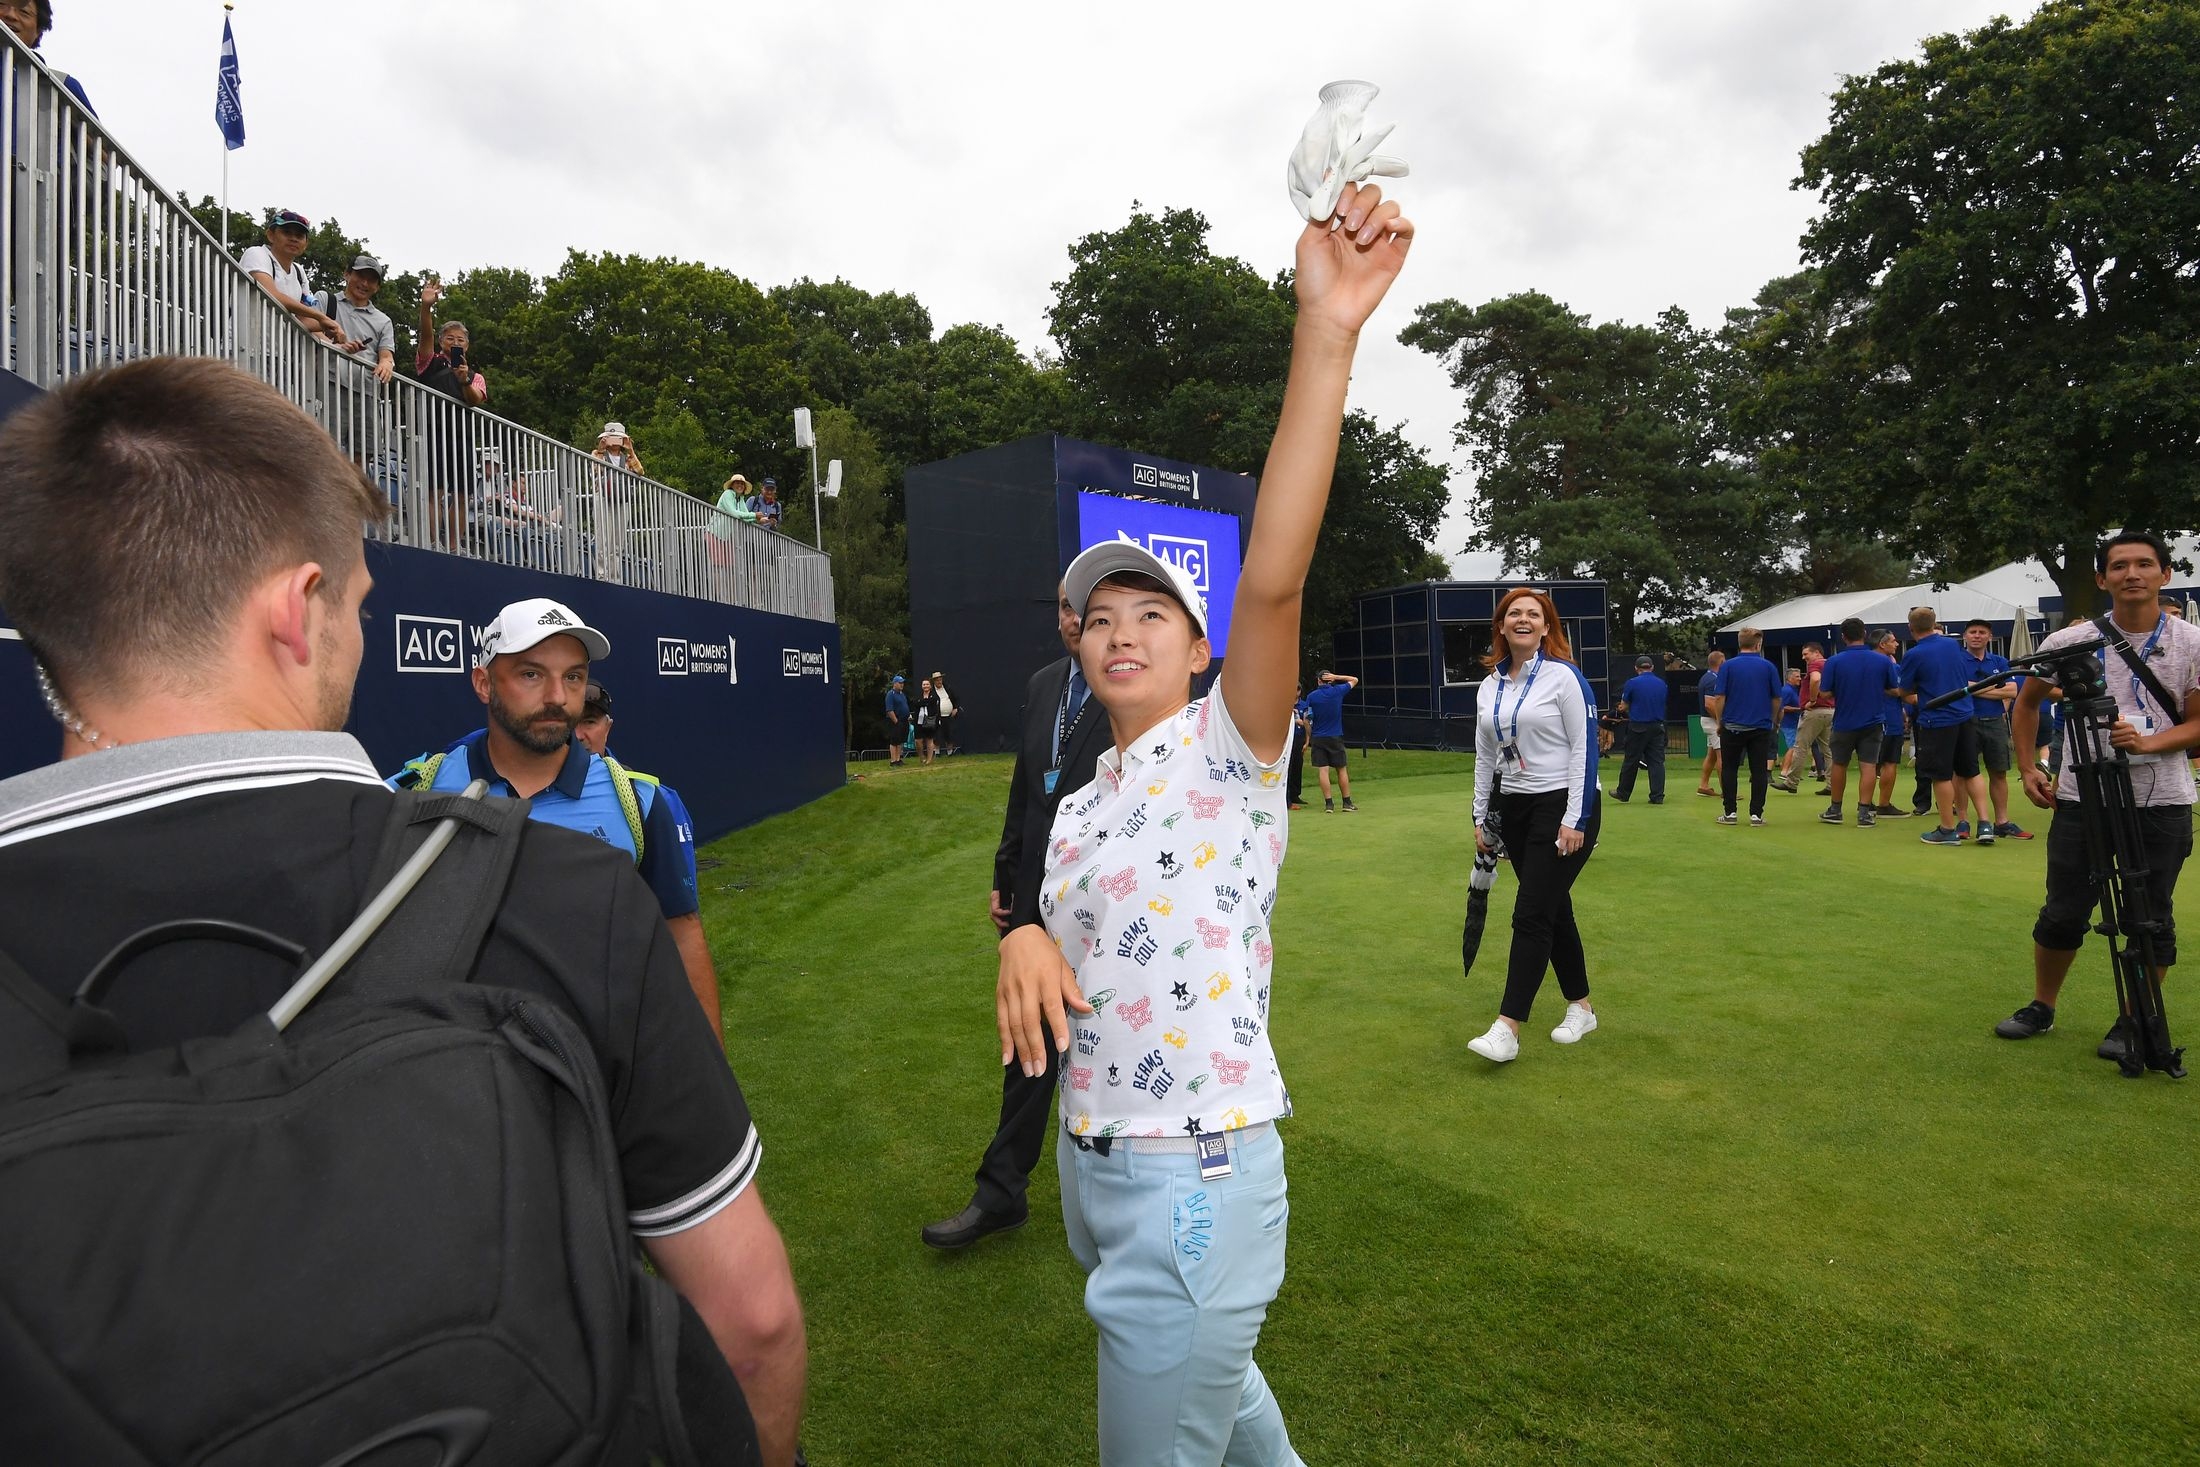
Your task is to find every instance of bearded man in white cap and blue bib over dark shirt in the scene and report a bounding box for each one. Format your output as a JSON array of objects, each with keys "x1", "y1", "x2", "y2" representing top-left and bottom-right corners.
[{"x1": 387, "y1": 598, "x2": 724, "y2": 1034}]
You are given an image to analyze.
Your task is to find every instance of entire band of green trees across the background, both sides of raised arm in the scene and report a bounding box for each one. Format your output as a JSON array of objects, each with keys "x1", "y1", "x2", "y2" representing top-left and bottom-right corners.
[{"x1": 196, "y1": 0, "x2": 2200, "y2": 712}]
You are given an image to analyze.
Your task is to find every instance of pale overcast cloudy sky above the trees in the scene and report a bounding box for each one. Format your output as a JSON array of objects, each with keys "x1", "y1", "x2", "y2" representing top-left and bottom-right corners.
[{"x1": 90, "y1": 0, "x2": 2031, "y2": 574}]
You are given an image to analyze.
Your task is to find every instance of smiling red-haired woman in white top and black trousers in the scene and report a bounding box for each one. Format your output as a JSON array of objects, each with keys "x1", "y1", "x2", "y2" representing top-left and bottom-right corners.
[{"x1": 1467, "y1": 585, "x2": 1599, "y2": 1065}]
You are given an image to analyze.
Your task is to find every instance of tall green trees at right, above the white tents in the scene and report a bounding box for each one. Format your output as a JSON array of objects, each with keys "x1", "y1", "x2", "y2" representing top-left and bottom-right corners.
[{"x1": 1404, "y1": 0, "x2": 2200, "y2": 653}]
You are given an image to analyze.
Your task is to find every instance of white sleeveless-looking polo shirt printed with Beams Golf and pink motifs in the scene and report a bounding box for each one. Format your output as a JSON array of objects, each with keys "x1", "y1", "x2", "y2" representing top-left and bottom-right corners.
[{"x1": 1038, "y1": 684, "x2": 1291, "y2": 1137}]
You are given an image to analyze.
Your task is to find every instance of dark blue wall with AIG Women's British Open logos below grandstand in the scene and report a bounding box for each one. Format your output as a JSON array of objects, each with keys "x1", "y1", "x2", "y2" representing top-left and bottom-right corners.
[{"x1": 0, "y1": 545, "x2": 847, "y2": 840}]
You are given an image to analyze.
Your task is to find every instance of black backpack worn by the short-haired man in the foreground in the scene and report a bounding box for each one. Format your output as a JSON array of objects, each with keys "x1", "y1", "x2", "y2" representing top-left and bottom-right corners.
[{"x1": 0, "y1": 785, "x2": 757, "y2": 1467}]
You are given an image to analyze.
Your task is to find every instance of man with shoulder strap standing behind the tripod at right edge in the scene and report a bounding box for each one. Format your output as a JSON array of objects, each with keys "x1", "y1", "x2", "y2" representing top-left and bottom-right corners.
[{"x1": 1993, "y1": 530, "x2": 2200, "y2": 1060}]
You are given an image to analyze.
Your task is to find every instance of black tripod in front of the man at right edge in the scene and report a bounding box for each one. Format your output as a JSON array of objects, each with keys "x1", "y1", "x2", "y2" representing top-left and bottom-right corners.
[{"x1": 1923, "y1": 638, "x2": 2185, "y2": 1080}]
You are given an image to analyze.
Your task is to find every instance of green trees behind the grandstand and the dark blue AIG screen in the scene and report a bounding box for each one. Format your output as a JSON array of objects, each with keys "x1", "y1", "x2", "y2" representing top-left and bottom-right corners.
[{"x1": 194, "y1": 198, "x2": 1450, "y2": 743}]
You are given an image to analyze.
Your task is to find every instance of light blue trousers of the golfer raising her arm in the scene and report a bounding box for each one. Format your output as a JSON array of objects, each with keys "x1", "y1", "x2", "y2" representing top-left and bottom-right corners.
[{"x1": 1054, "y1": 1126, "x2": 1302, "y2": 1467}]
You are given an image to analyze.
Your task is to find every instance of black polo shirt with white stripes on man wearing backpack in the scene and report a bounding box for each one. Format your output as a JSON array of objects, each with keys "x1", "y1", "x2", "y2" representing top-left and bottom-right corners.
[{"x1": 0, "y1": 732, "x2": 761, "y2": 1236}]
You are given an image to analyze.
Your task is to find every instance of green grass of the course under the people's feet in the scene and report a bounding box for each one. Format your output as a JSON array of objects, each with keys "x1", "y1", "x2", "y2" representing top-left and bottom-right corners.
[{"x1": 702, "y1": 752, "x2": 2200, "y2": 1467}]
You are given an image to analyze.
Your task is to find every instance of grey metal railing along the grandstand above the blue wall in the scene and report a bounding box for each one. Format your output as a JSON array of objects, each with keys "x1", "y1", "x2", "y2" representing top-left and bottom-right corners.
[{"x1": 0, "y1": 26, "x2": 834, "y2": 620}]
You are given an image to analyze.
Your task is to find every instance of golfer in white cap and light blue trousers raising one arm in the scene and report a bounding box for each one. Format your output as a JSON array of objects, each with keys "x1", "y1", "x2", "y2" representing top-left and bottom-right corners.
[{"x1": 999, "y1": 187, "x2": 1412, "y2": 1465}]
